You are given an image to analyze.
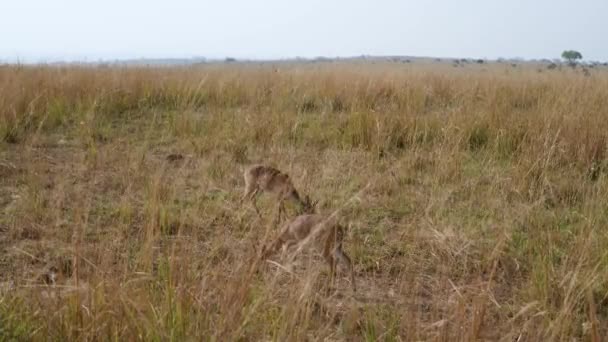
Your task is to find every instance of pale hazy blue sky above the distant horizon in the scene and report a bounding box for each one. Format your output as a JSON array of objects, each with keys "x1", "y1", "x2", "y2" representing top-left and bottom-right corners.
[{"x1": 0, "y1": 0, "x2": 608, "y2": 61}]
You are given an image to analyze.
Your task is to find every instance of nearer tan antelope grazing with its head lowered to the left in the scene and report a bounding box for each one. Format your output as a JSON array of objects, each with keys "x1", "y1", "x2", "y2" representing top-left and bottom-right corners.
[{"x1": 262, "y1": 214, "x2": 357, "y2": 292}]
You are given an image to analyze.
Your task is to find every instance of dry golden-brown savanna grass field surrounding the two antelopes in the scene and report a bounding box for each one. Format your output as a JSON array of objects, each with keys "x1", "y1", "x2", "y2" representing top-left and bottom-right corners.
[{"x1": 0, "y1": 62, "x2": 608, "y2": 342}]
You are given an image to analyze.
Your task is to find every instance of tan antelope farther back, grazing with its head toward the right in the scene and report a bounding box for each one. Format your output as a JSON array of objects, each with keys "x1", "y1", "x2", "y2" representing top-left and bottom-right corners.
[{"x1": 241, "y1": 165, "x2": 314, "y2": 222}]
